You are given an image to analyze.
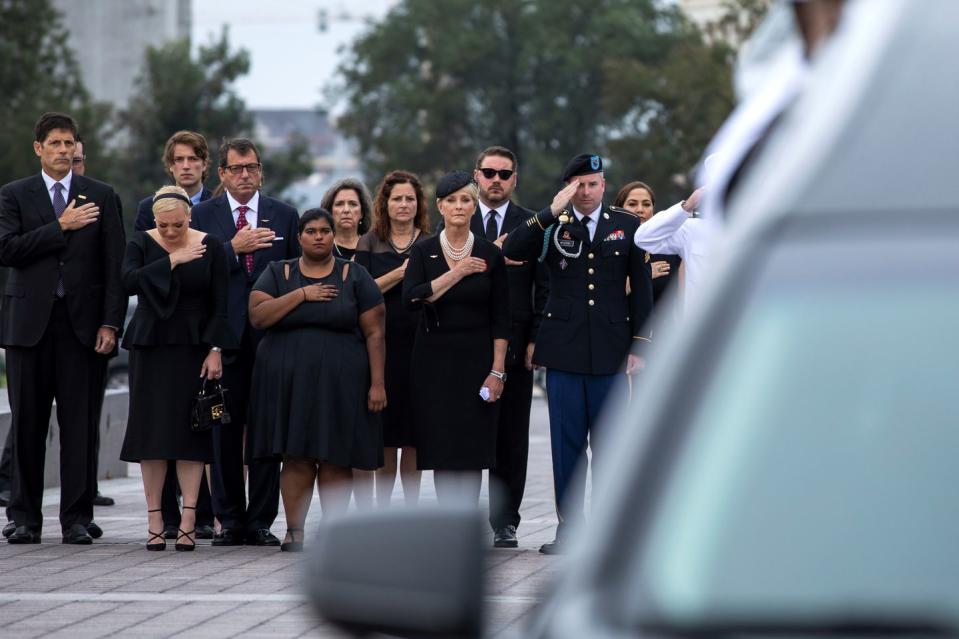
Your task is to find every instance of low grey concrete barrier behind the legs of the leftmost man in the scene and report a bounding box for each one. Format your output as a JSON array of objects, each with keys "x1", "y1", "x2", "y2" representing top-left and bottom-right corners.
[{"x1": 0, "y1": 389, "x2": 130, "y2": 488}]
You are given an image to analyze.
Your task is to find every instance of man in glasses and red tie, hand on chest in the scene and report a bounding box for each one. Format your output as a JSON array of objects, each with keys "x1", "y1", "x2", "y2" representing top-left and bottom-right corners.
[{"x1": 192, "y1": 138, "x2": 300, "y2": 546}]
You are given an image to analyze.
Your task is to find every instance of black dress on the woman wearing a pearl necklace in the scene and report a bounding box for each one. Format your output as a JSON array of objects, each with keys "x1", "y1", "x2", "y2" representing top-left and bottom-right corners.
[{"x1": 403, "y1": 237, "x2": 510, "y2": 470}]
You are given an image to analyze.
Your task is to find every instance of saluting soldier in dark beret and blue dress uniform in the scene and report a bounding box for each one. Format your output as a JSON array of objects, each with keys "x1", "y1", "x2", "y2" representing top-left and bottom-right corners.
[{"x1": 503, "y1": 154, "x2": 653, "y2": 554}]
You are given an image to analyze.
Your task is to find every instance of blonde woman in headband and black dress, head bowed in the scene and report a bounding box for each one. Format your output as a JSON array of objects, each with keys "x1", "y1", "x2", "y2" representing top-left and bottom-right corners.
[{"x1": 120, "y1": 186, "x2": 236, "y2": 550}]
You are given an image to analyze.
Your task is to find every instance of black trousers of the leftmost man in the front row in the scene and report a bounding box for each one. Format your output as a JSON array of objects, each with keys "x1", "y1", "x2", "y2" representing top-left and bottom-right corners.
[{"x1": 7, "y1": 301, "x2": 107, "y2": 531}]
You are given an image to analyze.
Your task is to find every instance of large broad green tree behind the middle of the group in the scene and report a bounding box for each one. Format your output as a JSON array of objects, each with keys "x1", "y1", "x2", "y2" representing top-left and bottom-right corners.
[{"x1": 329, "y1": 0, "x2": 731, "y2": 207}]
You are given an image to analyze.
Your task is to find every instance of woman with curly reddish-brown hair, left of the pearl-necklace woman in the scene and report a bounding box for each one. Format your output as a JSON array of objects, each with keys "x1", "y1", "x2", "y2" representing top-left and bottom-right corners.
[{"x1": 354, "y1": 171, "x2": 429, "y2": 507}]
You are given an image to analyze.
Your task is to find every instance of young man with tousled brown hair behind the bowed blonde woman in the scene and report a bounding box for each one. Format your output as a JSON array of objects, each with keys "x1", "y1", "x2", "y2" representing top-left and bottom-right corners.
[{"x1": 133, "y1": 131, "x2": 213, "y2": 539}]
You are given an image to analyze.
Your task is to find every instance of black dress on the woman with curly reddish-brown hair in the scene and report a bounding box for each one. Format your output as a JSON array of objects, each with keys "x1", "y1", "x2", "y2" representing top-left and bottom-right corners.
[{"x1": 353, "y1": 231, "x2": 429, "y2": 448}]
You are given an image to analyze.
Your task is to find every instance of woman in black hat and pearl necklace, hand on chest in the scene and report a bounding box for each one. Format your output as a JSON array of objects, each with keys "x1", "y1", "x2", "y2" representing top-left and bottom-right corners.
[{"x1": 403, "y1": 171, "x2": 510, "y2": 504}]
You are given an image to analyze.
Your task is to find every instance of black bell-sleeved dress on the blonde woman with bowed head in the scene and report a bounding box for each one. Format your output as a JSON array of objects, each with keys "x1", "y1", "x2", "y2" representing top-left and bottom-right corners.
[{"x1": 120, "y1": 231, "x2": 236, "y2": 463}]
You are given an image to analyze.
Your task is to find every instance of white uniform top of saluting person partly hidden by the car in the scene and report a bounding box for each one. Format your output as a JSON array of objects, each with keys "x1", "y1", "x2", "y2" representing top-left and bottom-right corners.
[{"x1": 633, "y1": 202, "x2": 718, "y2": 312}]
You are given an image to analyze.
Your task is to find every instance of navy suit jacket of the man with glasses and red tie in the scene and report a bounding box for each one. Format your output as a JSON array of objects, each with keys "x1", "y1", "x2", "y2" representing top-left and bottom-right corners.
[{"x1": 190, "y1": 193, "x2": 300, "y2": 341}]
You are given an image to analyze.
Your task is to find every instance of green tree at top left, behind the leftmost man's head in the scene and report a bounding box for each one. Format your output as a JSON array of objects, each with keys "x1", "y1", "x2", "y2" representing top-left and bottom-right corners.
[{"x1": 0, "y1": 0, "x2": 109, "y2": 184}]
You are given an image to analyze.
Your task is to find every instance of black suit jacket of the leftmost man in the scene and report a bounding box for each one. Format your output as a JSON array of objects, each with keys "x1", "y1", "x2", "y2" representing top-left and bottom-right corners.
[{"x1": 0, "y1": 173, "x2": 127, "y2": 348}]
